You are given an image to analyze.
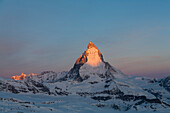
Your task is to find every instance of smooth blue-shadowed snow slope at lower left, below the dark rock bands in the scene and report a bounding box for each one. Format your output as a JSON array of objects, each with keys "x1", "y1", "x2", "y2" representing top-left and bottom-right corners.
[{"x1": 0, "y1": 92, "x2": 169, "y2": 113}]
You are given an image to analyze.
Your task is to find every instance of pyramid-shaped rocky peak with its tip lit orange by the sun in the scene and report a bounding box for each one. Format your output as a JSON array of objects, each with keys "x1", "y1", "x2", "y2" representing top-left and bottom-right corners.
[{"x1": 66, "y1": 42, "x2": 123, "y2": 82}]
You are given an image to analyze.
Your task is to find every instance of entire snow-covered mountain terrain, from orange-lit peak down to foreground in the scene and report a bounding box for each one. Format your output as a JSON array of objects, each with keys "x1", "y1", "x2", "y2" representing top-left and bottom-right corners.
[{"x1": 0, "y1": 42, "x2": 170, "y2": 113}]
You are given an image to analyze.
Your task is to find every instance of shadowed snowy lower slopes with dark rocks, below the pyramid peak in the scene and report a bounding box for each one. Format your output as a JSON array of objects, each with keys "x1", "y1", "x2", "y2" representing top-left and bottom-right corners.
[{"x1": 0, "y1": 74, "x2": 170, "y2": 113}]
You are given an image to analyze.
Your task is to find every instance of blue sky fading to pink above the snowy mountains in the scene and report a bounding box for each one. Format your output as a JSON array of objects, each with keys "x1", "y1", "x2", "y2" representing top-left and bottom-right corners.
[{"x1": 0, "y1": 0, "x2": 170, "y2": 77}]
